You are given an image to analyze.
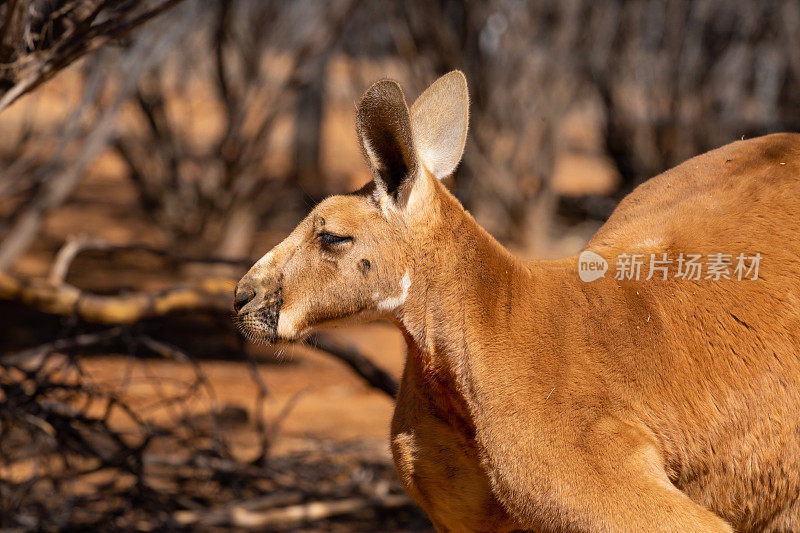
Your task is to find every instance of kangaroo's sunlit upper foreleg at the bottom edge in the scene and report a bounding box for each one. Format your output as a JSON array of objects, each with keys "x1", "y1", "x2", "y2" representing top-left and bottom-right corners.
[{"x1": 494, "y1": 420, "x2": 733, "y2": 533}]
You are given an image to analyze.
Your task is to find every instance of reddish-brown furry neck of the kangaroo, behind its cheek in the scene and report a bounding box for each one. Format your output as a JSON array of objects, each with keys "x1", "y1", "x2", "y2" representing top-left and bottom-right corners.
[{"x1": 399, "y1": 184, "x2": 535, "y2": 387}]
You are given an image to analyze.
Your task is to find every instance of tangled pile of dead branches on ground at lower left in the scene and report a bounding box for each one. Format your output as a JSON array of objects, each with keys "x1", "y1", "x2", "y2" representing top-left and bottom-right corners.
[{"x1": 0, "y1": 330, "x2": 413, "y2": 530}]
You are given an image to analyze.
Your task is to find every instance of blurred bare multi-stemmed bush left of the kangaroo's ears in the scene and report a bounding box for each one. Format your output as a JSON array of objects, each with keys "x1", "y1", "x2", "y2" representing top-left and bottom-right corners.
[{"x1": 114, "y1": 0, "x2": 357, "y2": 257}]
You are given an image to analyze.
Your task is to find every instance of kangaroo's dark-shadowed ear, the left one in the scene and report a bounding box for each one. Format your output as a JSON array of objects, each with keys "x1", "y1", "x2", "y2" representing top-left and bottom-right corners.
[{"x1": 356, "y1": 80, "x2": 417, "y2": 199}]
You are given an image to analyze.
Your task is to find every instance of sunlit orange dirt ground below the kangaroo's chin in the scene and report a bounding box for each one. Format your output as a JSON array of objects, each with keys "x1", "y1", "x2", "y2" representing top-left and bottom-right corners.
[{"x1": 83, "y1": 323, "x2": 405, "y2": 461}]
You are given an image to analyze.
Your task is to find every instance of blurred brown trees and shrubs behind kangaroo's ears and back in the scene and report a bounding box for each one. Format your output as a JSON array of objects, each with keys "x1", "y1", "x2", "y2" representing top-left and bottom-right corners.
[{"x1": 0, "y1": 0, "x2": 800, "y2": 267}]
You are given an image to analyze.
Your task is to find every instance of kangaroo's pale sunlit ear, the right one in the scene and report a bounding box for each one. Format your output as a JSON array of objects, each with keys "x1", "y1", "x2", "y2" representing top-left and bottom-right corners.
[{"x1": 411, "y1": 70, "x2": 469, "y2": 179}]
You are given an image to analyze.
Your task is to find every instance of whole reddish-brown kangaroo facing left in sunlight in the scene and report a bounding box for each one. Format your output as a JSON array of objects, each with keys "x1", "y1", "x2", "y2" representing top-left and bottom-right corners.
[{"x1": 234, "y1": 71, "x2": 800, "y2": 532}]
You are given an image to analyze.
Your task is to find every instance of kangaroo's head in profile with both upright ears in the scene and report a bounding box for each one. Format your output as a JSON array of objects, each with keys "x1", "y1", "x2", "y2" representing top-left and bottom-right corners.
[{"x1": 234, "y1": 71, "x2": 469, "y2": 342}]
